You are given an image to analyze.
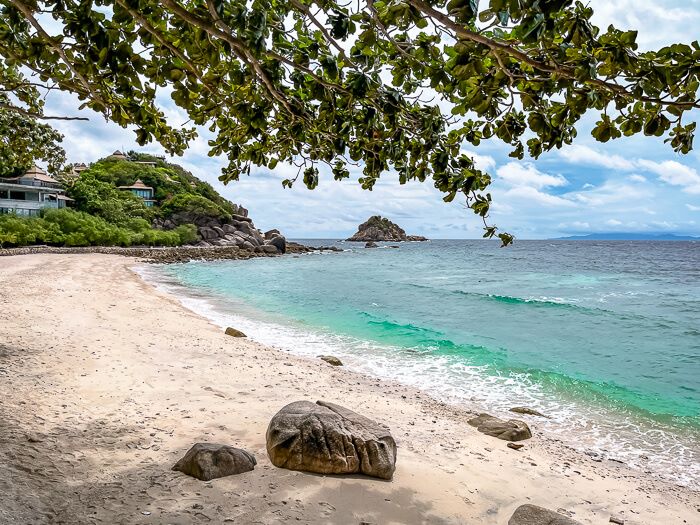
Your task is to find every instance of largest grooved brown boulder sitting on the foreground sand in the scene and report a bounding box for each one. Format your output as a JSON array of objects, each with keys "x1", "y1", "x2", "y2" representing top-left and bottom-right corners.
[{"x1": 266, "y1": 401, "x2": 396, "y2": 479}]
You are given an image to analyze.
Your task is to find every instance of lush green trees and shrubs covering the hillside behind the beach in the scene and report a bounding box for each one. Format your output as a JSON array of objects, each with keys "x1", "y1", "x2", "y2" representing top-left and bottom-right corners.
[{"x1": 0, "y1": 152, "x2": 241, "y2": 247}]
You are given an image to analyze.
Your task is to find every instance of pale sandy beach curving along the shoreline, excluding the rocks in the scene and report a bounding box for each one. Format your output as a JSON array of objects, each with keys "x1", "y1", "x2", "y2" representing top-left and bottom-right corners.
[{"x1": 0, "y1": 254, "x2": 700, "y2": 525}]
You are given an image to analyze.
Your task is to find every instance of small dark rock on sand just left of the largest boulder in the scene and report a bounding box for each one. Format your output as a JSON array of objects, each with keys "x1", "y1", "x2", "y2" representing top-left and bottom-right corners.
[{"x1": 172, "y1": 443, "x2": 256, "y2": 481}]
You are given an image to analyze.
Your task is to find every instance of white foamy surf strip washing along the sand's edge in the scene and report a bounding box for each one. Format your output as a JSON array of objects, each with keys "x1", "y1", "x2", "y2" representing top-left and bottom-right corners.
[{"x1": 136, "y1": 266, "x2": 700, "y2": 485}]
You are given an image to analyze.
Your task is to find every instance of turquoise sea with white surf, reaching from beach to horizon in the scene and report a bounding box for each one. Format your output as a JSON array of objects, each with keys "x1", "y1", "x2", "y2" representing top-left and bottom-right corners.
[{"x1": 143, "y1": 240, "x2": 700, "y2": 485}]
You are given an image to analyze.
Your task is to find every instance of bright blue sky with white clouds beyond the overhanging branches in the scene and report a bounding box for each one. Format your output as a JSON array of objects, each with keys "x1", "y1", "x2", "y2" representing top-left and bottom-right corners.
[{"x1": 41, "y1": 0, "x2": 700, "y2": 239}]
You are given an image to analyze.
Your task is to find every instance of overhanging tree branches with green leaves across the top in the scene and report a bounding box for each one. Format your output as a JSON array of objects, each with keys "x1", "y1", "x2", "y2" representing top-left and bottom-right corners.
[{"x1": 0, "y1": 0, "x2": 700, "y2": 244}]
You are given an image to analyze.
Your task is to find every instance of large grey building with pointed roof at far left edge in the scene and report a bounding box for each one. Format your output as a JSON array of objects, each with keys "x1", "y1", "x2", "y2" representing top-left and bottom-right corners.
[{"x1": 0, "y1": 165, "x2": 72, "y2": 216}]
